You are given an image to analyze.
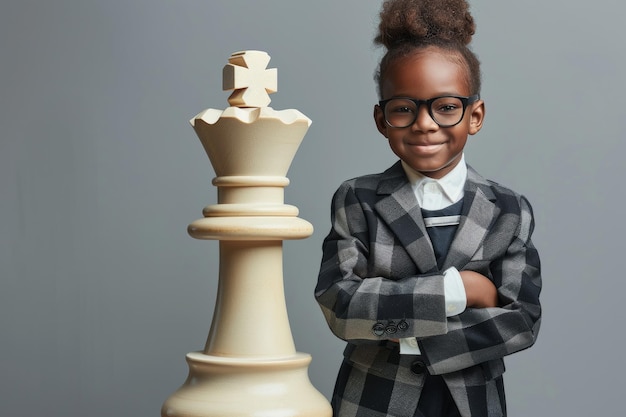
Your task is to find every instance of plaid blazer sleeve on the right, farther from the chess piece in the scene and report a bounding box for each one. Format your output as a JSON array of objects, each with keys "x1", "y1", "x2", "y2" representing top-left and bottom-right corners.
[{"x1": 420, "y1": 197, "x2": 541, "y2": 374}]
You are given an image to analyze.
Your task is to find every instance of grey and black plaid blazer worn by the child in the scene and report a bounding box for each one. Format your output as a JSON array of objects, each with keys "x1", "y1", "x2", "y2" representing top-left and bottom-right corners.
[{"x1": 315, "y1": 162, "x2": 541, "y2": 417}]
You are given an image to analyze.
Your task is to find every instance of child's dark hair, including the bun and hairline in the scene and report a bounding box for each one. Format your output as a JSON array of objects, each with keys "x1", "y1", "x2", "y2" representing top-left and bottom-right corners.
[{"x1": 374, "y1": 0, "x2": 481, "y2": 98}]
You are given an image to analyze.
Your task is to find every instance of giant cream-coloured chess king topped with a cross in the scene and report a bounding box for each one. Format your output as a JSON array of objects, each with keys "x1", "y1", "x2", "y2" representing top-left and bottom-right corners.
[{"x1": 161, "y1": 51, "x2": 332, "y2": 417}]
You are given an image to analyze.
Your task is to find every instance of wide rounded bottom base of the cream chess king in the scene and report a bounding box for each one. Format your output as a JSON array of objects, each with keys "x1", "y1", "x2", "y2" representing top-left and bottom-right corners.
[{"x1": 161, "y1": 352, "x2": 332, "y2": 417}]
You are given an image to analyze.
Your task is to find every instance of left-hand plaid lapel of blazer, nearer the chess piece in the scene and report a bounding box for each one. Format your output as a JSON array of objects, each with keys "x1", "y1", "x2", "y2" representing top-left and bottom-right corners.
[{"x1": 375, "y1": 162, "x2": 437, "y2": 273}]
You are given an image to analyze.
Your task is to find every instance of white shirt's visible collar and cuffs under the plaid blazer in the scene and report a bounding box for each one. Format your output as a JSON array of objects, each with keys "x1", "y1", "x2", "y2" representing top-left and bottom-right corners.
[{"x1": 400, "y1": 155, "x2": 467, "y2": 355}]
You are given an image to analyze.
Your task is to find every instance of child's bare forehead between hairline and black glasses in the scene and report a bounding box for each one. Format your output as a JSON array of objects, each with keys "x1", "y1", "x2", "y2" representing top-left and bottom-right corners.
[{"x1": 382, "y1": 48, "x2": 469, "y2": 99}]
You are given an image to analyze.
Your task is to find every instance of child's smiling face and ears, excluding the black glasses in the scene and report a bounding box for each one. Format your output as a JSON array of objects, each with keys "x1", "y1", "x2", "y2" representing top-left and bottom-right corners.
[{"x1": 374, "y1": 47, "x2": 485, "y2": 178}]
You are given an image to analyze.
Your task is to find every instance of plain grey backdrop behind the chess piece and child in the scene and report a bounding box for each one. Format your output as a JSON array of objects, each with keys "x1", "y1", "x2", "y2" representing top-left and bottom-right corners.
[{"x1": 0, "y1": 0, "x2": 626, "y2": 417}]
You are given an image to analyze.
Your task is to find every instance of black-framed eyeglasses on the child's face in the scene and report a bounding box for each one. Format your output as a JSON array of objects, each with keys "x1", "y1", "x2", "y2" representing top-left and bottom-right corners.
[{"x1": 378, "y1": 94, "x2": 480, "y2": 128}]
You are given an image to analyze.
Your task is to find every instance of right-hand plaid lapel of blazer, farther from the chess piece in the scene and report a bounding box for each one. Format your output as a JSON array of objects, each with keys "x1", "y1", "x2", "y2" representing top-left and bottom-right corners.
[{"x1": 442, "y1": 166, "x2": 500, "y2": 270}]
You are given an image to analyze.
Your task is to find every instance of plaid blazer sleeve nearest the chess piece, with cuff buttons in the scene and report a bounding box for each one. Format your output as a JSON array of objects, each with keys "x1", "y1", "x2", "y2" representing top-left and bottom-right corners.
[{"x1": 315, "y1": 182, "x2": 447, "y2": 343}]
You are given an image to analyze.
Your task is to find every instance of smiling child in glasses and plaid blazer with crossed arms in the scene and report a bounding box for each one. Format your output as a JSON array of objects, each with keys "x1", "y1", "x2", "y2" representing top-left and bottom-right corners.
[{"x1": 315, "y1": 0, "x2": 541, "y2": 417}]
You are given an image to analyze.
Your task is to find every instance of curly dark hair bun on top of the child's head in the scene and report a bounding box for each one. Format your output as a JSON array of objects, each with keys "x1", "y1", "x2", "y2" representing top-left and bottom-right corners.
[{"x1": 374, "y1": 0, "x2": 476, "y2": 49}]
